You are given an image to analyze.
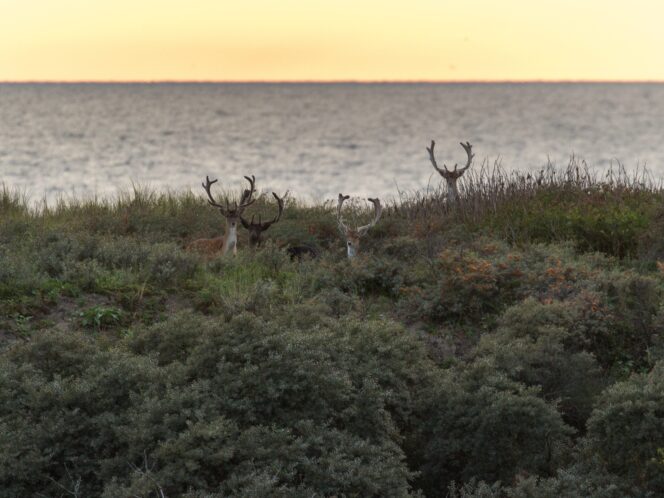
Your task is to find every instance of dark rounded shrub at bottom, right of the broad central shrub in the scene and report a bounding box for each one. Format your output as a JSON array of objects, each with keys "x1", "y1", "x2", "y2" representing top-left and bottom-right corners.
[{"x1": 419, "y1": 364, "x2": 573, "y2": 496}]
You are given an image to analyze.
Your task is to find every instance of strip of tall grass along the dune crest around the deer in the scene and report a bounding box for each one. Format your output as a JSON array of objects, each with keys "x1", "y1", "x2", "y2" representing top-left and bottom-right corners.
[{"x1": 0, "y1": 161, "x2": 664, "y2": 257}]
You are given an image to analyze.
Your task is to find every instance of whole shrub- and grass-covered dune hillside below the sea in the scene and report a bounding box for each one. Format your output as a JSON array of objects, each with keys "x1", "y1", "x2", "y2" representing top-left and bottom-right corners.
[{"x1": 0, "y1": 163, "x2": 664, "y2": 498}]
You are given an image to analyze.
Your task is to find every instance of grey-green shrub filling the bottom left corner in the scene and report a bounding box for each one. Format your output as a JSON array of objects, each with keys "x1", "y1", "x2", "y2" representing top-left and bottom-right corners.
[{"x1": 0, "y1": 334, "x2": 159, "y2": 497}]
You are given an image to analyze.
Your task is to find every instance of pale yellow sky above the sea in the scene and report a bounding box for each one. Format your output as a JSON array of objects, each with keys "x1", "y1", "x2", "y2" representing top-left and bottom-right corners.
[{"x1": 0, "y1": 0, "x2": 664, "y2": 81}]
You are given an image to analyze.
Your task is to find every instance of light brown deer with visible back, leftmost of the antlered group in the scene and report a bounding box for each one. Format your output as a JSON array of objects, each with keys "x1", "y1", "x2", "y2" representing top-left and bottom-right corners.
[{"x1": 187, "y1": 175, "x2": 256, "y2": 256}]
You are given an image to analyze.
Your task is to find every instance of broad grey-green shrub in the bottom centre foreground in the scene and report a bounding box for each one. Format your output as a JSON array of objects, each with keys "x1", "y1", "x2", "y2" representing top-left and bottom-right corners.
[{"x1": 120, "y1": 315, "x2": 427, "y2": 496}]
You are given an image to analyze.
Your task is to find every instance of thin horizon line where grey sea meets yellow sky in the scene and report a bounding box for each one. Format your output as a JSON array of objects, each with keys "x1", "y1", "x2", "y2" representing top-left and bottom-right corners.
[{"x1": 0, "y1": 79, "x2": 664, "y2": 85}]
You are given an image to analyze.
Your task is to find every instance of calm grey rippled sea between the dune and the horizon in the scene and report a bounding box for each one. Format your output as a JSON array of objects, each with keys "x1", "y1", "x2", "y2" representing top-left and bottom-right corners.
[{"x1": 0, "y1": 84, "x2": 664, "y2": 200}]
